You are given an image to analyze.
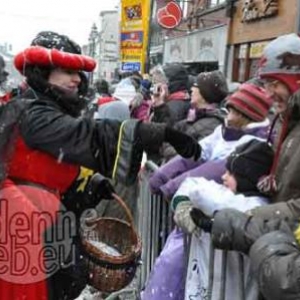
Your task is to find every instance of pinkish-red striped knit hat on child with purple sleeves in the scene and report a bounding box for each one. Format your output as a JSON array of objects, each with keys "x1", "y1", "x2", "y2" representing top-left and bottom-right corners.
[{"x1": 226, "y1": 83, "x2": 272, "y2": 122}]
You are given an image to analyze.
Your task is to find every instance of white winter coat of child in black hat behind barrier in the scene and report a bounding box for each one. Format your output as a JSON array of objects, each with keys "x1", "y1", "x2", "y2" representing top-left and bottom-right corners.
[{"x1": 176, "y1": 177, "x2": 267, "y2": 300}]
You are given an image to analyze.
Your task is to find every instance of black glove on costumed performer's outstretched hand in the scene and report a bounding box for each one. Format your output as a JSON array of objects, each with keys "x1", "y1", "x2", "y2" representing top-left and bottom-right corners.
[{"x1": 165, "y1": 127, "x2": 201, "y2": 160}]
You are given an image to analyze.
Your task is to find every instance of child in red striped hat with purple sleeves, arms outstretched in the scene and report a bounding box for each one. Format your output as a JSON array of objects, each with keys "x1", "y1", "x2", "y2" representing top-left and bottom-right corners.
[{"x1": 149, "y1": 83, "x2": 273, "y2": 199}]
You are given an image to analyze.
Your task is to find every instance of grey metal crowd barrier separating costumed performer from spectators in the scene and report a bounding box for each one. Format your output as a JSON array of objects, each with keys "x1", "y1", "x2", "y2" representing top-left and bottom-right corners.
[{"x1": 107, "y1": 161, "x2": 246, "y2": 300}]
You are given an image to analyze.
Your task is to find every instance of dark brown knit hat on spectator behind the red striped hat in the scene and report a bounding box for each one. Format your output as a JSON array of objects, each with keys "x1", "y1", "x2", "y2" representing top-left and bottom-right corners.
[{"x1": 194, "y1": 71, "x2": 228, "y2": 103}]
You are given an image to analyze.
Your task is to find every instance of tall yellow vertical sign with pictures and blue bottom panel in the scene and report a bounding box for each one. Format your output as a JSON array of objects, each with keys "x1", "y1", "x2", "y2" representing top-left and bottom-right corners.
[{"x1": 120, "y1": 0, "x2": 151, "y2": 73}]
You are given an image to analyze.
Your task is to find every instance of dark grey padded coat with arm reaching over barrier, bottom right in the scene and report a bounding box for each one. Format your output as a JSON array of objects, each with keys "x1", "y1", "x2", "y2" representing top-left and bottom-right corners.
[{"x1": 212, "y1": 209, "x2": 300, "y2": 300}]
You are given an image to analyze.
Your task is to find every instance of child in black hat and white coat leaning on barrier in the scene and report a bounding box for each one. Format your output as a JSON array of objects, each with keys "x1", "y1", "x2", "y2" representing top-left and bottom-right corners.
[{"x1": 173, "y1": 140, "x2": 273, "y2": 300}]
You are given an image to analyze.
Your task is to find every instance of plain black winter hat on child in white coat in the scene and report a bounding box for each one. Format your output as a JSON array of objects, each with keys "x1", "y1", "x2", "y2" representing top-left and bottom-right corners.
[{"x1": 226, "y1": 139, "x2": 274, "y2": 194}]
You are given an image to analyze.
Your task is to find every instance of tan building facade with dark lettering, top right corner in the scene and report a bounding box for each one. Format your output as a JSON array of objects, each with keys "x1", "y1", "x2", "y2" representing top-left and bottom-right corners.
[{"x1": 226, "y1": 0, "x2": 300, "y2": 82}]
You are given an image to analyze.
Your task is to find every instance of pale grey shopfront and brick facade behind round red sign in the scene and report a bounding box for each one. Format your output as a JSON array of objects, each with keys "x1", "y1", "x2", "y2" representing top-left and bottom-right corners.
[{"x1": 150, "y1": 0, "x2": 228, "y2": 74}]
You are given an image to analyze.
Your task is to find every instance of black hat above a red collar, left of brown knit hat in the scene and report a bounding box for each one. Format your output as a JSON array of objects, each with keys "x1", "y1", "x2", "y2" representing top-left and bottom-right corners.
[{"x1": 163, "y1": 63, "x2": 189, "y2": 94}]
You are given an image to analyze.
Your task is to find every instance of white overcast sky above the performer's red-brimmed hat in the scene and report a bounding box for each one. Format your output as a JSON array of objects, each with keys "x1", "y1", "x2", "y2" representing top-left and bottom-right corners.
[{"x1": 0, "y1": 0, "x2": 120, "y2": 53}]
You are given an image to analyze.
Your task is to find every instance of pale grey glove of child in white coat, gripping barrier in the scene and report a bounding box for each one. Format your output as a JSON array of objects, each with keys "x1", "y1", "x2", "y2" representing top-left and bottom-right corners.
[{"x1": 173, "y1": 196, "x2": 197, "y2": 234}]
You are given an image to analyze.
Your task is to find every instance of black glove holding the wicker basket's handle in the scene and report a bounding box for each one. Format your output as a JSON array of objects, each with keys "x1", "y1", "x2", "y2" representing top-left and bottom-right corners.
[{"x1": 86, "y1": 173, "x2": 115, "y2": 204}]
